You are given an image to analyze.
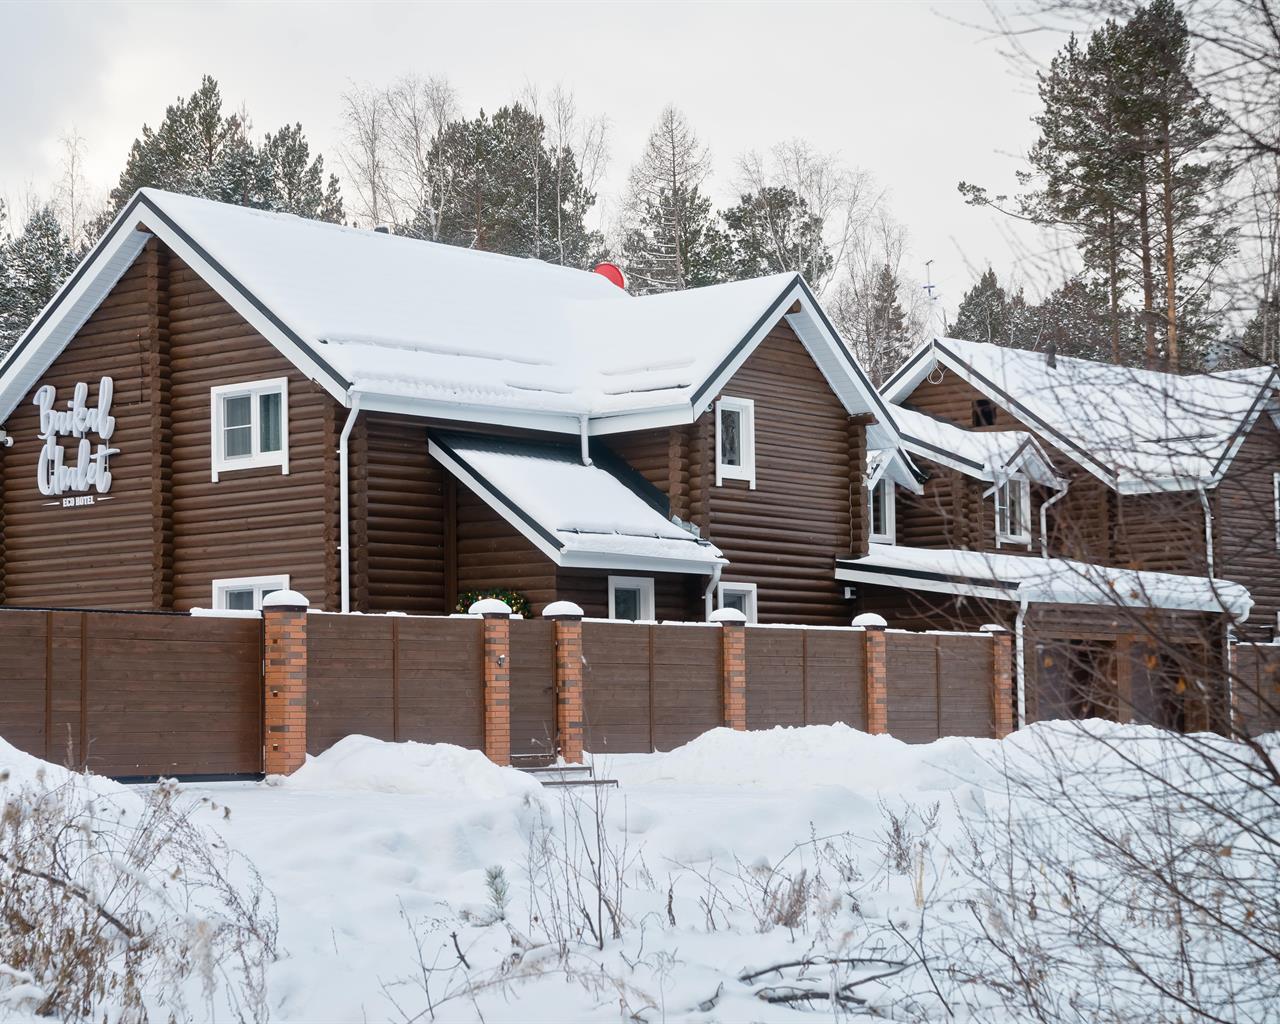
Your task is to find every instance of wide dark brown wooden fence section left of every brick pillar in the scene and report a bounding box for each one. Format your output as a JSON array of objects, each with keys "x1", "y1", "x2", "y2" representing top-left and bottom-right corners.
[{"x1": 0, "y1": 609, "x2": 262, "y2": 777}]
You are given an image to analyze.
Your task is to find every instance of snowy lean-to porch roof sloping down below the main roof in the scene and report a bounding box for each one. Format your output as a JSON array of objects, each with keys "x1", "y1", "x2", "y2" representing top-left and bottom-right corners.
[{"x1": 430, "y1": 433, "x2": 727, "y2": 573}]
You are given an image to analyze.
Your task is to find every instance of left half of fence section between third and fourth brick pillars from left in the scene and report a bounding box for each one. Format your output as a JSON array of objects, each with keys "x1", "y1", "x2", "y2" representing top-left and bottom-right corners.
[{"x1": 582, "y1": 621, "x2": 653, "y2": 754}]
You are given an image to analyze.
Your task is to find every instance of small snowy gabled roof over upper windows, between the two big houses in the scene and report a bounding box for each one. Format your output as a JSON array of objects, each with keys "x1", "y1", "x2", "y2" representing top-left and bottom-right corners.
[{"x1": 893, "y1": 406, "x2": 1066, "y2": 489}]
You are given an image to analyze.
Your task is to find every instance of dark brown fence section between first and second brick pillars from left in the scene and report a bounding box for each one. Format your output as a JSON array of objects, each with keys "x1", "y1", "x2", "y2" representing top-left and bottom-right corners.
[{"x1": 307, "y1": 613, "x2": 486, "y2": 754}]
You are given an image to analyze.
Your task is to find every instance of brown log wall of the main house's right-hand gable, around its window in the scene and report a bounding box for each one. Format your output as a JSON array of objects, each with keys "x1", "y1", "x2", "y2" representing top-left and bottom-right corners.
[{"x1": 694, "y1": 325, "x2": 863, "y2": 626}]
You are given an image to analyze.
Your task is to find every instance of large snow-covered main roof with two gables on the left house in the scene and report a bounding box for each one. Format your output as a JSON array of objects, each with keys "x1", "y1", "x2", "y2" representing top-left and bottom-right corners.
[{"x1": 0, "y1": 188, "x2": 897, "y2": 447}]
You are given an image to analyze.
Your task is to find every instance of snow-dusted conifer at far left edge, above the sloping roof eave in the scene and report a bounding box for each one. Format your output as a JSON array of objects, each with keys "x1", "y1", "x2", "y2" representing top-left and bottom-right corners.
[{"x1": 0, "y1": 205, "x2": 76, "y2": 352}]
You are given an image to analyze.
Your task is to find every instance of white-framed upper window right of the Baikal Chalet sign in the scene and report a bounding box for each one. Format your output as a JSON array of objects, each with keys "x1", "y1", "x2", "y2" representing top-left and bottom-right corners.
[{"x1": 210, "y1": 376, "x2": 289, "y2": 483}]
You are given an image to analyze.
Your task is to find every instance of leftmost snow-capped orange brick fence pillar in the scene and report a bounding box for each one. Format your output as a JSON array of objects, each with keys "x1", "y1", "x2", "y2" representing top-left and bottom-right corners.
[{"x1": 262, "y1": 590, "x2": 310, "y2": 776}]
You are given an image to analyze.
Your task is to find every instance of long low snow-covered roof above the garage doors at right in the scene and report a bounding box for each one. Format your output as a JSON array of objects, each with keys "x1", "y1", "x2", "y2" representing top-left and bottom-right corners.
[{"x1": 836, "y1": 544, "x2": 1253, "y2": 622}]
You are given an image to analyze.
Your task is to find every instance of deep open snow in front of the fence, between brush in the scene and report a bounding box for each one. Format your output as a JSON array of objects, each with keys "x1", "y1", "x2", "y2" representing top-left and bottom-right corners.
[{"x1": 0, "y1": 726, "x2": 1280, "y2": 1021}]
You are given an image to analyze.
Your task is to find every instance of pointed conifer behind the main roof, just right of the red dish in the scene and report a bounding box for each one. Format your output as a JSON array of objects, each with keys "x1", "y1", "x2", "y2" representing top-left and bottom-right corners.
[{"x1": 622, "y1": 106, "x2": 728, "y2": 293}]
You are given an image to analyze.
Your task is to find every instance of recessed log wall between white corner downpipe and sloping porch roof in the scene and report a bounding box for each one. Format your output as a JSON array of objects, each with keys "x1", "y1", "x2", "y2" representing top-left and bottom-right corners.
[{"x1": 352, "y1": 413, "x2": 453, "y2": 614}]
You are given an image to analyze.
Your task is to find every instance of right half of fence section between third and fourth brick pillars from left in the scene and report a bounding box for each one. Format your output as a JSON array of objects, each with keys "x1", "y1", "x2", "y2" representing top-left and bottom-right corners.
[{"x1": 650, "y1": 626, "x2": 727, "y2": 750}]
